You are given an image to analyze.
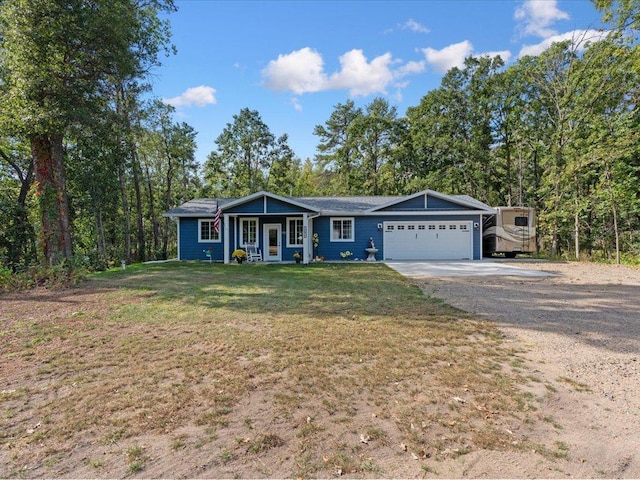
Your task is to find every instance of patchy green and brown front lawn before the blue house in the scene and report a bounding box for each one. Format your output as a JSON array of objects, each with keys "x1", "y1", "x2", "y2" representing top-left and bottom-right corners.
[{"x1": 0, "y1": 263, "x2": 556, "y2": 477}]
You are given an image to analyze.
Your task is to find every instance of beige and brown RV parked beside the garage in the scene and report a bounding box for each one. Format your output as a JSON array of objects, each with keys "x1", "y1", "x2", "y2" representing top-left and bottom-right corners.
[{"x1": 482, "y1": 207, "x2": 536, "y2": 258}]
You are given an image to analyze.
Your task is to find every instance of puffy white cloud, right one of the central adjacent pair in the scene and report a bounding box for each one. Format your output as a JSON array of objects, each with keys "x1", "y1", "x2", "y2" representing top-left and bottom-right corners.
[{"x1": 329, "y1": 49, "x2": 394, "y2": 97}]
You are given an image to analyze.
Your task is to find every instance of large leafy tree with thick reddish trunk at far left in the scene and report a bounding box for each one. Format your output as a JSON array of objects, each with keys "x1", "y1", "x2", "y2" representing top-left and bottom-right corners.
[{"x1": 0, "y1": 0, "x2": 174, "y2": 264}]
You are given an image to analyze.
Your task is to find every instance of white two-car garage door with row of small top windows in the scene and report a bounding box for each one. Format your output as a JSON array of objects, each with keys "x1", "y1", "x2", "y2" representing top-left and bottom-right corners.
[{"x1": 383, "y1": 220, "x2": 473, "y2": 260}]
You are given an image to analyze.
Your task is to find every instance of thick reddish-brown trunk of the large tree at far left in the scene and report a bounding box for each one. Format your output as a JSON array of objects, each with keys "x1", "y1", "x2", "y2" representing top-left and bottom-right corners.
[{"x1": 31, "y1": 135, "x2": 73, "y2": 265}]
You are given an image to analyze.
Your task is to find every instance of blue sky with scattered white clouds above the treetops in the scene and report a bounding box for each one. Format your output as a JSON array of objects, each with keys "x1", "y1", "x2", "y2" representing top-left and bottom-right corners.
[{"x1": 152, "y1": 0, "x2": 601, "y2": 162}]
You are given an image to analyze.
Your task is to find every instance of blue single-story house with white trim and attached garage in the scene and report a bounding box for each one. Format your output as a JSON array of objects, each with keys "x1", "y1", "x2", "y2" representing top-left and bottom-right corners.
[{"x1": 164, "y1": 190, "x2": 496, "y2": 263}]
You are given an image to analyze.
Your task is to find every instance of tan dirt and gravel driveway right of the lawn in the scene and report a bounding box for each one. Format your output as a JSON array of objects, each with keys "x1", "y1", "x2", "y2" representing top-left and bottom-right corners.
[{"x1": 416, "y1": 260, "x2": 640, "y2": 478}]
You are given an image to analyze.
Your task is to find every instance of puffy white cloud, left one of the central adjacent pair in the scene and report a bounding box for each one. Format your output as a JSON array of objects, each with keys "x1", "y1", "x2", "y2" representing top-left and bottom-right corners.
[{"x1": 262, "y1": 47, "x2": 327, "y2": 94}]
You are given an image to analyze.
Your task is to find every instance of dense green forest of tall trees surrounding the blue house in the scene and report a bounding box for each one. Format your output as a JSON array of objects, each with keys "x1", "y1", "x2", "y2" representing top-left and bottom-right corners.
[{"x1": 0, "y1": 0, "x2": 640, "y2": 285}]
